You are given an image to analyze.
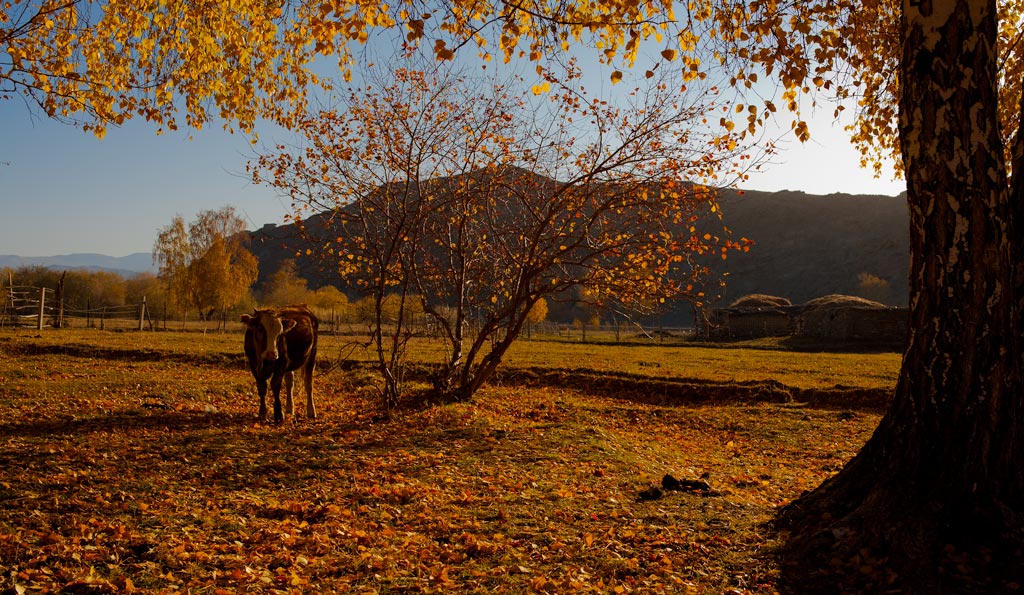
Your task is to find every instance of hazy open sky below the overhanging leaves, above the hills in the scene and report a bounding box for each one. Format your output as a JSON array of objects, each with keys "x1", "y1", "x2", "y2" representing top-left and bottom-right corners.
[{"x1": 0, "y1": 68, "x2": 905, "y2": 256}]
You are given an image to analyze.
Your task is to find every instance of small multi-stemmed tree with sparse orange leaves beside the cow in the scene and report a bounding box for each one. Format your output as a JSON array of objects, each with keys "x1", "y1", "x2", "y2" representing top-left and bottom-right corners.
[{"x1": 253, "y1": 58, "x2": 745, "y2": 407}]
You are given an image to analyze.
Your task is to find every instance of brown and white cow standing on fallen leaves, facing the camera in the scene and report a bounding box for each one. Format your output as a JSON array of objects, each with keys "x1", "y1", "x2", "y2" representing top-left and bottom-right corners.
[{"x1": 242, "y1": 304, "x2": 319, "y2": 423}]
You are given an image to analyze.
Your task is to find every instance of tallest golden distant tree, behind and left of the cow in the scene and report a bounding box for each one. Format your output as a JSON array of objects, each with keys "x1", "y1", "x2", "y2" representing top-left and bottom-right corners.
[{"x1": 153, "y1": 207, "x2": 257, "y2": 321}]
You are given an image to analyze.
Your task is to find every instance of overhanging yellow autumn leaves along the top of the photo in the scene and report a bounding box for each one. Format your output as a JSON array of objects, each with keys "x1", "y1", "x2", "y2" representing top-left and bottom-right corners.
[{"x1": 0, "y1": 0, "x2": 1024, "y2": 178}]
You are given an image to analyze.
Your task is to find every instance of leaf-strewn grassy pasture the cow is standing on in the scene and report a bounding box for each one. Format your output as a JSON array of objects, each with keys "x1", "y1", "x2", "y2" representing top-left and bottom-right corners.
[{"x1": 0, "y1": 331, "x2": 899, "y2": 594}]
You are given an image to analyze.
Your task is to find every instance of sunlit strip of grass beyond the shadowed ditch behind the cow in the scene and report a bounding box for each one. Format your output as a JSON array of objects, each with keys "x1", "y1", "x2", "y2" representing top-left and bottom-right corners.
[{"x1": 0, "y1": 330, "x2": 900, "y2": 389}]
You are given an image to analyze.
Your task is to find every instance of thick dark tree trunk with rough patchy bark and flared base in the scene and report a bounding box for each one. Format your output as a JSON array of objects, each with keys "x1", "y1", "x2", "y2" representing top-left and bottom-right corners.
[{"x1": 778, "y1": 0, "x2": 1024, "y2": 593}]
